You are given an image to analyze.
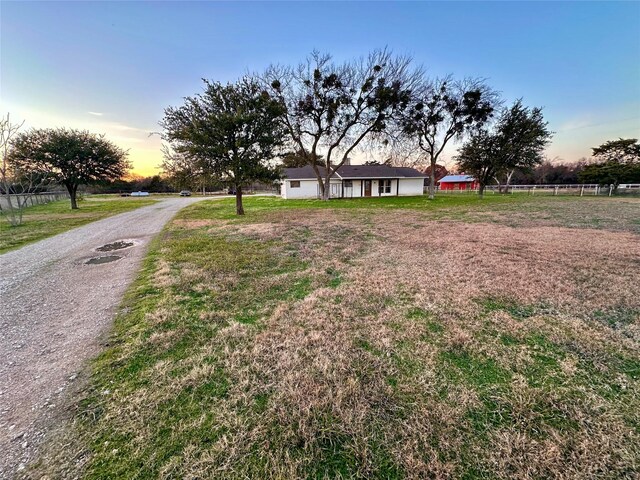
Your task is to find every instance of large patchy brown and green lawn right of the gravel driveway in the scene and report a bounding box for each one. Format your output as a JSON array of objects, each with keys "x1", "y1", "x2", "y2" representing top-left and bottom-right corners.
[{"x1": 29, "y1": 196, "x2": 640, "y2": 479}]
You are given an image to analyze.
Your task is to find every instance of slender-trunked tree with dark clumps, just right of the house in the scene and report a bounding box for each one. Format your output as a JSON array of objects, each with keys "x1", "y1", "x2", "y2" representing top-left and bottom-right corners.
[{"x1": 401, "y1": 76, "x2": 499, "y2": 199}]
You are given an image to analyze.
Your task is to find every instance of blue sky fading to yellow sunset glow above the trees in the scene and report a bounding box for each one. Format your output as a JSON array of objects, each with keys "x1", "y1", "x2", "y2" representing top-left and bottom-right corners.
[{"x1": 0, "y1": 1, "x2": 640, "y2": 175}]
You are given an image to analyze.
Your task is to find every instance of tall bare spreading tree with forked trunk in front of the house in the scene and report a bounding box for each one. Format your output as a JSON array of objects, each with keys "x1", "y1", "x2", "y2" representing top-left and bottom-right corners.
[{"x1": 264, "y1": 50, "x2": 421, "y2": 200}]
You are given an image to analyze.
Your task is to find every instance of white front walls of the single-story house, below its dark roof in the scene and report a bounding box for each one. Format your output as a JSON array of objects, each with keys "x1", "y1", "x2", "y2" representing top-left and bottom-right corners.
[{"x1": 280, "y1": 178, "x2": 424, "y2": 199}]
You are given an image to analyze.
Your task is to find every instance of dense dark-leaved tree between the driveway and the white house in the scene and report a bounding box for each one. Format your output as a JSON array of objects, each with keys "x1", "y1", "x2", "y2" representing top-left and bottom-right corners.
[{"x1": 160, "y1": 77, "x2": 285, "y2": 215}]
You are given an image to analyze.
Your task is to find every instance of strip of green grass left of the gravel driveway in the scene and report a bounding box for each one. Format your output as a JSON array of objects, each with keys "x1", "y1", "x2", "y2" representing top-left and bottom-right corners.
[{"x1": 0, "y1": 195, "x2": 156, "y2": 253}]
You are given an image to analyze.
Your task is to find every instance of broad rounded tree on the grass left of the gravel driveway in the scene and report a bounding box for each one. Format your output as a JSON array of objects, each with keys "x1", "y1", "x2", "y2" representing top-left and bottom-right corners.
[{"x1": 10, "y1": 128, "x2": 131, "y2": 209}]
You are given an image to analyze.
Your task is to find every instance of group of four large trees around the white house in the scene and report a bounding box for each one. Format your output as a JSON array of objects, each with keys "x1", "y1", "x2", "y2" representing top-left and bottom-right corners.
[{"x1": 161, "y1": 50, "x2": 551, "y2": 215}]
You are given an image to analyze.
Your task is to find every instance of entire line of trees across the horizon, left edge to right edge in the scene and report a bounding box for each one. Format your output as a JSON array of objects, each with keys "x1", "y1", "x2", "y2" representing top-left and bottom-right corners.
[{"x1": 0, "y1": 49, "x2": 640, "y2": 220}]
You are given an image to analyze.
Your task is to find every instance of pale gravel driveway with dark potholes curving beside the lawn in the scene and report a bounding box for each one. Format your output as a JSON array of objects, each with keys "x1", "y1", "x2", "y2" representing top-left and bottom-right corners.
[{"x1": 0, "y1": 198, "x2": 210, "y2": 478}]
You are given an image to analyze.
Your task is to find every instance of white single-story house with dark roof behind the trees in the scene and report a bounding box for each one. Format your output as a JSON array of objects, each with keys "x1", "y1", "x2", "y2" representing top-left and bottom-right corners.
[{"x1": 280, "y1": 165, "x2": 425, "y2": 198}]
